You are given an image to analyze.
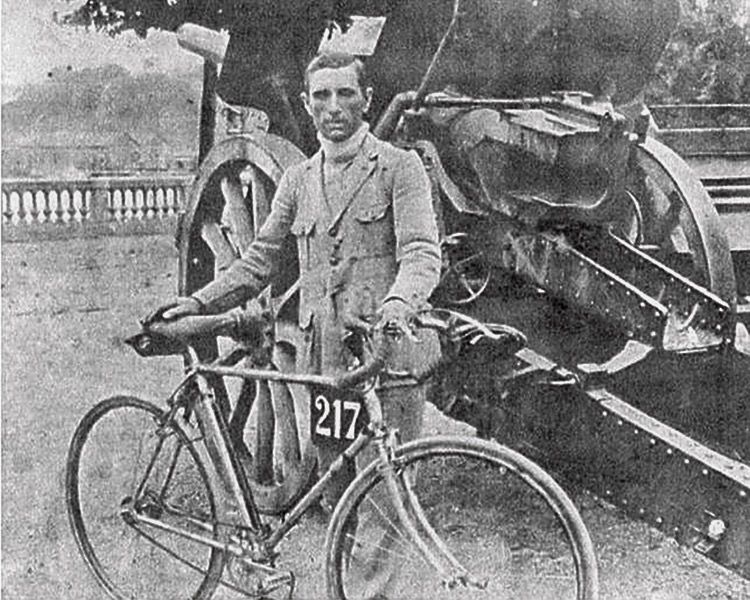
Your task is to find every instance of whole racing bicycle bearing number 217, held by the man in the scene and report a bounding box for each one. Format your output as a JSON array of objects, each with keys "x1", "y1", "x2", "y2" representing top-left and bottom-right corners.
[{"x1": 66, "y1": 311, "x2": 598, "y2": 600}]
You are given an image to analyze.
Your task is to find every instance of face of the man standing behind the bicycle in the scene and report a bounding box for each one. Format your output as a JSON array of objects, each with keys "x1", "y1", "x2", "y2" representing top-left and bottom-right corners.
[{"x1": 302, "y1": 64, "x2": 372, "y2": 142}]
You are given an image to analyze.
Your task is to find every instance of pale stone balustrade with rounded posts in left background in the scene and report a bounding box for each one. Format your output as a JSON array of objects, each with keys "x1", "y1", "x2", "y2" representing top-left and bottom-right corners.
[{"x1": 2, "y1": 175, "x2": 192, "y2": 241}]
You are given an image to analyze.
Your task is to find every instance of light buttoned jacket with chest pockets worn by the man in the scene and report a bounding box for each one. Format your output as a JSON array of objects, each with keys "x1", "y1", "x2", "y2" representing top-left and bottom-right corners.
[{"x1": 193, "y1": 133, "x2": 441, "y2": 378}]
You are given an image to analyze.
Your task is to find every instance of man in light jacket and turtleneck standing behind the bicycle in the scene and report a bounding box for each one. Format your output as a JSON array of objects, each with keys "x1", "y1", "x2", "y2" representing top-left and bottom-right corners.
[{"x1": 160, "y1": 53, "x2": 440, "y2": 505}]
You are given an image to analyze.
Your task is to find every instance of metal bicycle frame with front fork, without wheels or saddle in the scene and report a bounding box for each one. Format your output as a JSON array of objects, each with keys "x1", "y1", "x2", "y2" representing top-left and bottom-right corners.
[{"x1": 123, "y1": 342, "x2": 486, "y2": 588}]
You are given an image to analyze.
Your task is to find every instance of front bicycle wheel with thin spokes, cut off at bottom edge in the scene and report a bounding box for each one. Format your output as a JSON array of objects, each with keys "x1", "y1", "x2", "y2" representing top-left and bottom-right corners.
[{"x1": 326, "y1": 437, "x2": 598, "y2": 600}]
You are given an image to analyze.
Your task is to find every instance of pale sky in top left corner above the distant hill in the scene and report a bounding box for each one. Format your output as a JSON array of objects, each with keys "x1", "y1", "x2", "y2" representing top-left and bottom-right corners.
[{"x1": 0, "y1": 0, "x2": 199, "y2": 88}]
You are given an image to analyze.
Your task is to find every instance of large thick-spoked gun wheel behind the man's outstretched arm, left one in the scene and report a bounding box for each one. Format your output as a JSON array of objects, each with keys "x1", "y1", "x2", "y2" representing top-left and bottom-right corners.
[{"x1": 178, "y1": 134, "x2": 315, "y2": 514}]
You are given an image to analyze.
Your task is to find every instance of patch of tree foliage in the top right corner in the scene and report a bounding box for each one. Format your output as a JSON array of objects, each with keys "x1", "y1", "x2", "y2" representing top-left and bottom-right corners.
[{"x1": 647, "y1": 0, "x2": 750, "y2": 103}]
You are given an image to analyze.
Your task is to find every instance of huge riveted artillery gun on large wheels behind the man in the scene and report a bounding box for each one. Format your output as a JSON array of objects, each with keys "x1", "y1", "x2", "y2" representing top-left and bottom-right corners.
[{"x1": 172, "y1": 0, "x2": 750, "y2": 578}]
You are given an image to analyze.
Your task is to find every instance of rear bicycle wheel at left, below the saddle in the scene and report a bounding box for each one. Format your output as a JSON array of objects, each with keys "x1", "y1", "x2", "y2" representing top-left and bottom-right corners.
[{"x1": 65, "y1": 396, "x2": 223, "y2": 600}]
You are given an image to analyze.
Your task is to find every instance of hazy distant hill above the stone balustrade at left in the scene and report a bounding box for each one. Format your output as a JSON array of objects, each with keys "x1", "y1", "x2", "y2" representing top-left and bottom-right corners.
[{"x1": 2, "y1": 65, "x2": 202, "y2": 176}]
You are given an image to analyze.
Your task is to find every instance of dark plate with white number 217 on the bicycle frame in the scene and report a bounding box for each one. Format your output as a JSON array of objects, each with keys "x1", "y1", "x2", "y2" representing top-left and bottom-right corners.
[{"x1": 310, "y1": 386, "x2": 367, "y2": 449}]
